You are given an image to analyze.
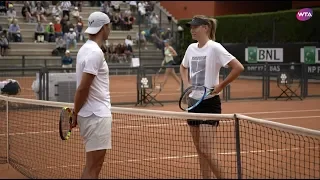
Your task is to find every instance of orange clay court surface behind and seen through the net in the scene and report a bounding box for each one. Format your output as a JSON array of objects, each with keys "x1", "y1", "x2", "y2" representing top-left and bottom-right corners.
[{"x1": 0, "y1": 76, "x2": 320, "y2": 178}]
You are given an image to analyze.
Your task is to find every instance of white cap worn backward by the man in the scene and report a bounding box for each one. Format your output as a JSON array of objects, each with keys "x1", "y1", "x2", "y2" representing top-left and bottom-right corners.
[{"x1": 85, "y1": 12, "x2": 110, "y2": 34}]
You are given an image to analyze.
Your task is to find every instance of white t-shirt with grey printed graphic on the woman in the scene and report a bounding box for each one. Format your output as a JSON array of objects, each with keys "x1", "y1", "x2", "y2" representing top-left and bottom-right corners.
[{"x1": 181, "y1": 40, "x2": 235, "y2": 98}]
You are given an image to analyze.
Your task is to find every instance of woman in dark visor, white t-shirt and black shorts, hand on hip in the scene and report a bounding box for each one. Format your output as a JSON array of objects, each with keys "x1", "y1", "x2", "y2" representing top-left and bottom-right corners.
[{"x1": 180, "y1": 16, "x2": 244, "y2": 179}]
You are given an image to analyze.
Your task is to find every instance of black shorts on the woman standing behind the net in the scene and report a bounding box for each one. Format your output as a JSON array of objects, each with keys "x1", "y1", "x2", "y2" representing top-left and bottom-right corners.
[{"x1": 187, "y1": 96, "x2": 221, "y2": 126}]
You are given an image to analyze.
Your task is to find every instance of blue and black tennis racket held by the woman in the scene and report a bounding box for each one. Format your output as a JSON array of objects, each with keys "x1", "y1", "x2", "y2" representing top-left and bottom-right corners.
[{"x1": 179, "y1": 86, "x2": 214, "y2": 111}]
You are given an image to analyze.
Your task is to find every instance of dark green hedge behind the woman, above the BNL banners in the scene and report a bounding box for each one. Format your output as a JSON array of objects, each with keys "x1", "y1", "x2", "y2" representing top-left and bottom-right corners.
[{"x1": 179, "y1": 8, "x2": 320, "y2": 51}]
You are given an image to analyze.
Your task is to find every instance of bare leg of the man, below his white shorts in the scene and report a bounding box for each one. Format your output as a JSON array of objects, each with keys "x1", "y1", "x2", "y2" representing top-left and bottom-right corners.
[{"x1": 81, "y1": 149, "x2": 106, "y2": 179}]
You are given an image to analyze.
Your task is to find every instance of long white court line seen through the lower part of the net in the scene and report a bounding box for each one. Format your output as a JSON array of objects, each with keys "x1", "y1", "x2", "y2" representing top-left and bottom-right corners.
[{"x1": 31, "y1": 147, "x2": 319, "y2": 170}]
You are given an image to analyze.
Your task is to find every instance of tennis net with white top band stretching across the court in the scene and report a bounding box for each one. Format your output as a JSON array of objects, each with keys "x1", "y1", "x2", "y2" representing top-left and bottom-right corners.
[{"x1": 0, "y1": 96, "x2": 320, "y2": 179}]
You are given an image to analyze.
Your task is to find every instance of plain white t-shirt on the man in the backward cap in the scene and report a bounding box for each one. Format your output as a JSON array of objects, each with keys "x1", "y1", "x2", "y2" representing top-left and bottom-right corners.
[{"x1": 76, "y1": 40, "x2": 112, "y2": 117}]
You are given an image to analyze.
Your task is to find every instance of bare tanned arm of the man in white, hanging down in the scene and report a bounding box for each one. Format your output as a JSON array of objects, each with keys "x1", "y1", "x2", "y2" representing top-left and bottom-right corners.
[{"x1": 74, "y1": 73, "x2": 95, "y2": 114}]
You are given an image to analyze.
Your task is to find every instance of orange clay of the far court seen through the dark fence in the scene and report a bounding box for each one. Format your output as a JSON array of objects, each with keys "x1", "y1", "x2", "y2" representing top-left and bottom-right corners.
[{"x1": 0, "y1": 75, "x2": 320, "y2": 103}]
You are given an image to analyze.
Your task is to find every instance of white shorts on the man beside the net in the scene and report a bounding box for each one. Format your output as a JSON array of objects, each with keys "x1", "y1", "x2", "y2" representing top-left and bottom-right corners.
[{"x1": 78, "y1": 114, "x2": 112, "y2": 152}]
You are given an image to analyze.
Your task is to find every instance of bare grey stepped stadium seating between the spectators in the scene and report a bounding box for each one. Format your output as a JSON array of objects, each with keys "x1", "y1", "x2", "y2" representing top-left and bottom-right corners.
[{"x1": 0, "y1": 2, "x2": 163, "y2": 64}]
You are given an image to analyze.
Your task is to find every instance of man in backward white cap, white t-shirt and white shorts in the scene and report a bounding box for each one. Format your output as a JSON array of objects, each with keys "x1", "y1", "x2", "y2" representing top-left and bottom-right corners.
[{"x1": 73, "y1": 12, "x2": 112, "y2": 179}]
